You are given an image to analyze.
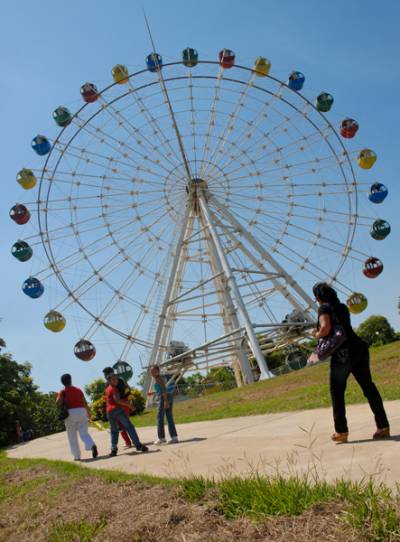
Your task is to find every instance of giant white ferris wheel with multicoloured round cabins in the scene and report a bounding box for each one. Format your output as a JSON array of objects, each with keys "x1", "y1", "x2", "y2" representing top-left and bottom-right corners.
[{"x1": 10, "y1": 48, "x2": 390, "y2": 385}]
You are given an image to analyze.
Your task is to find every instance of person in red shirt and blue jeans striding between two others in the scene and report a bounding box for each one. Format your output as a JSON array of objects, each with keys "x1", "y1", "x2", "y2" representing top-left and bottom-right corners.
[{"x1": 106, "y1": 374, "x2": 148, "y2": 457}]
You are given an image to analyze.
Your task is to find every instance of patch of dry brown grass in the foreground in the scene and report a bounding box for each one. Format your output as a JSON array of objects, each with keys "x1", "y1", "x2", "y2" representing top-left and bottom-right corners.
[{"x1": 0, "y1": 467, "x2": 363, "y2": 542}]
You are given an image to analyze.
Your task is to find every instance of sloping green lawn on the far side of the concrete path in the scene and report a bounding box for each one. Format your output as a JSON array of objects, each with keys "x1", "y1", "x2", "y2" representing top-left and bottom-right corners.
[{"x1": 132, "y1": 341, "x2": 400, "y2": 427}]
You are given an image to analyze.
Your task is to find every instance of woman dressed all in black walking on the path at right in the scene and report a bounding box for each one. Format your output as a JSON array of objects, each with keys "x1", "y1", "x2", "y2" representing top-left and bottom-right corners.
[{"x1": 313, "y1": 282, "x2": 390, "y2": 442}]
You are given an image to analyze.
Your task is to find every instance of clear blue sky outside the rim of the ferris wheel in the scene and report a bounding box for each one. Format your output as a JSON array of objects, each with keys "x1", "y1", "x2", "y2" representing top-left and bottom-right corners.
[{"x1": 0, "y1": 0, "x2": 400, "y2": 390}]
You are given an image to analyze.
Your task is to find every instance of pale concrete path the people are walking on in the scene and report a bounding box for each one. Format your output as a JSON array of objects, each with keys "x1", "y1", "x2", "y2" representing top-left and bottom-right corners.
[{"x1": 8, "y1": 401, "x2": 400, "y2": 486}]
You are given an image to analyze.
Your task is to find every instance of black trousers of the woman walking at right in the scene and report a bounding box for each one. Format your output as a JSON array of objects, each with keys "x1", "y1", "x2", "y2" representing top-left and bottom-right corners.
[{"x1": 330, "y1": 342, "x2": 389, "y2": 433}]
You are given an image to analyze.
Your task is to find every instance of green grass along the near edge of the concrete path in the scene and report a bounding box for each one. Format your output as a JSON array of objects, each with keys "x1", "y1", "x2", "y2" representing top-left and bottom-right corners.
[{"x1": 0, "y1": 453, "x2": 400, "y2": 542}]
